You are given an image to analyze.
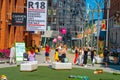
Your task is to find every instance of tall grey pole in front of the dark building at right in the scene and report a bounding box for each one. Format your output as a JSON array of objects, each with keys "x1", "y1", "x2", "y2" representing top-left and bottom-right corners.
[{"x1": 106, "y1": 0, "x2": 110, "y2": 47}]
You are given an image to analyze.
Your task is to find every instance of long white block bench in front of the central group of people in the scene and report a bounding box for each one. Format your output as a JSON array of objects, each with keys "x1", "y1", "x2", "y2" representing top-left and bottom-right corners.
[{"x1": 52, "y1": 62, "x2": 72, "y2": 69}]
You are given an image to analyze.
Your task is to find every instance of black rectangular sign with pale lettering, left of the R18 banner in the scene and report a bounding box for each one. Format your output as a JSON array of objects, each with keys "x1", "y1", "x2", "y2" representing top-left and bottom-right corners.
[{"x1": 12, "y1": 13, "x2": 27, "y2": 26}]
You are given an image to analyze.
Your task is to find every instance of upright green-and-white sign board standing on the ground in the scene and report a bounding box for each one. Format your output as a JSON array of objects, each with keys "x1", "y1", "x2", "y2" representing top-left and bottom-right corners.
[{"x1": 15, "y1": 42, "x2": 25, "y2": 62}]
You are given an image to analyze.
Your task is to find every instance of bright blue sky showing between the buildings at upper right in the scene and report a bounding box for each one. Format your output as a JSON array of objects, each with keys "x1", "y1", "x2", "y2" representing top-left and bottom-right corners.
[{"x1": 86, "y1": 0, "x2": 104, "y2": 20}]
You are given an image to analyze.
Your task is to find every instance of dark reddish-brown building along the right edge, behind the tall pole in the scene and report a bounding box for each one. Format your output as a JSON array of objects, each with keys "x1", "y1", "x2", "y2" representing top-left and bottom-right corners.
[{"x1": 104, "y1": 0, "x2": 120, "y2": 47}]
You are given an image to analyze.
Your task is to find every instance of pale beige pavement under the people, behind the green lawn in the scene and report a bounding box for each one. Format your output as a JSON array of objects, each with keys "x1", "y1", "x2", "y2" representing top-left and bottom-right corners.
[{"x1": 0, "y1": 50, "x2": 120, "y2": 73}]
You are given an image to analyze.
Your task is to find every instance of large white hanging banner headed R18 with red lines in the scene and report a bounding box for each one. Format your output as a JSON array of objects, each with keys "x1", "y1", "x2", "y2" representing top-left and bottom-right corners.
[{"x1": 27, "y1": 0, "x2": 47, "y2": 31}]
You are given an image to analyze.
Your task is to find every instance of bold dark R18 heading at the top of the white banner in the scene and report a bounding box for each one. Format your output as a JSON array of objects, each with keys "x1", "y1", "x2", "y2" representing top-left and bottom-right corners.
[{"x1": 28, "y1": 1, "x2": 45, "y2": 9}]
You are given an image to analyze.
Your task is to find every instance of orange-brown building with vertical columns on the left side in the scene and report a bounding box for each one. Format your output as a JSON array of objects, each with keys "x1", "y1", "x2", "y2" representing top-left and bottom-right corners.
[{"x1": 0, "y1": 0, "x2": 40, "y2": 49}]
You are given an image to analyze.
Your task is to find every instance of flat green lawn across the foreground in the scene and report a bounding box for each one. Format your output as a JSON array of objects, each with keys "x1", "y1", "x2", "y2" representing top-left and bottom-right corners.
[{"x1": 0, "y1": 66, "x2": 120, "y2": 80}]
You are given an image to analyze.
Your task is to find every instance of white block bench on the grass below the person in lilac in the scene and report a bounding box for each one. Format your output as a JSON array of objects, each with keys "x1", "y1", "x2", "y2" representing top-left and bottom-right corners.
[{"x1": 20, "y1": 61, "x2": 38, "y2": 71}]
